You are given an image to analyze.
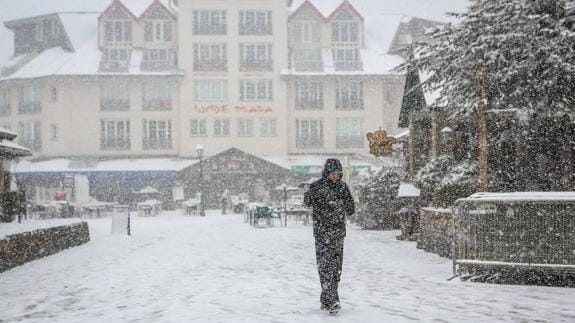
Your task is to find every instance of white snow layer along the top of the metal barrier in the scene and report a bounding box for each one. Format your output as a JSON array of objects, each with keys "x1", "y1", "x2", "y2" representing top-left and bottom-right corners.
[{"x1": 459, "y1": 192, "x2": 575, "y2": 202}]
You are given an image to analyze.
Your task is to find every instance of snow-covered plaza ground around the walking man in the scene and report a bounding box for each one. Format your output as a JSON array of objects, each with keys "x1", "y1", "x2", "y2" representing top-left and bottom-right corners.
[{"x1": 0, "y1": 212, "x2": 575, "y2": 322}]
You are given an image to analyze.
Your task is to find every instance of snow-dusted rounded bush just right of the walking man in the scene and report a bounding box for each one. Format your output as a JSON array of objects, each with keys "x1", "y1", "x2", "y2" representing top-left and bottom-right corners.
[{"x1": 352, "y1": 168, "x2": 401, "y2": 230}]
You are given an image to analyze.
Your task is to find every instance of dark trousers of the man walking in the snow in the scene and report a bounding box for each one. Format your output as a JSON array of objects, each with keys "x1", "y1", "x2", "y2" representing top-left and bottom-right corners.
[{"x1": 315, "y1": 237, "x2": 344, "y2": 307}]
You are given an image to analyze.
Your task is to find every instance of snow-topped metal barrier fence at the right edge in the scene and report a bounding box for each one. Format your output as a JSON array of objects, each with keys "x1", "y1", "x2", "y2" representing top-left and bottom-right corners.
[{"x1": 453, "y1": 192, "x2": 575, "y2": 274}]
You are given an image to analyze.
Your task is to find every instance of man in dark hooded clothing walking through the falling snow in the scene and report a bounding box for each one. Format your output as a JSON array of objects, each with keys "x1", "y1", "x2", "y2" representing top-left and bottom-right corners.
[{"x1": 304, "y1": 159, "x2": 355, "y2": 314}]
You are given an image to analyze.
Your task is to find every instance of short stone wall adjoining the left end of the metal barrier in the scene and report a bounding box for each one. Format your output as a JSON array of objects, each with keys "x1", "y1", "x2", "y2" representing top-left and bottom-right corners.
[{"x1": 417, "y1": 208, "x2": 453, "y2": 258}]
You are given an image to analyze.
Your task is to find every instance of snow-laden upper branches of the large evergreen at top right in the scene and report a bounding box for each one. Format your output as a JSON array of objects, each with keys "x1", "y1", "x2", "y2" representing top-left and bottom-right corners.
[{"x1": 409, "y1": 0, "x2": 575, "y2": 116}]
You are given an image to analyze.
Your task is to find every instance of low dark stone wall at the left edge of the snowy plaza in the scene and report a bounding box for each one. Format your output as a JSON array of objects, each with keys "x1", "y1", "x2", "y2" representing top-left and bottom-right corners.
[{"x1": 0, "y1": 222, "x2": 90, "y2": 273}]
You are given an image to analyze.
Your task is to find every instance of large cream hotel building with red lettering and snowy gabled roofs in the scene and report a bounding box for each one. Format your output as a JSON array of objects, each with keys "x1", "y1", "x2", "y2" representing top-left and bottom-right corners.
[{"x1": 0, "y1": 0, "x2": 450, "y2": 205}]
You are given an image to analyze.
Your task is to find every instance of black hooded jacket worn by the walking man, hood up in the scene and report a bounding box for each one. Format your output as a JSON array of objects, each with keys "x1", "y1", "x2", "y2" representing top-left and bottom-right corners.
[{"x1": 304, "y1": 159, "x2": 355, "y2": 238}]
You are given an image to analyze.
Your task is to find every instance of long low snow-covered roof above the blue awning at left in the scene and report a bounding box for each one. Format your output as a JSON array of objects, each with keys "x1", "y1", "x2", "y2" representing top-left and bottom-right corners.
[{"x1": 12, "y1": 158, "x2": 198, "y2": 173}]
